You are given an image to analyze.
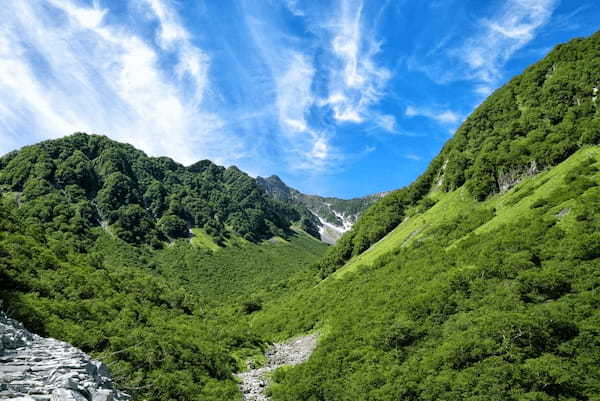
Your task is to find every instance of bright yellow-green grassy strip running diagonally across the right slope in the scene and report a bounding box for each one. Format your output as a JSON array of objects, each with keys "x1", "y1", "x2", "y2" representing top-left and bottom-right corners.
[{"x1": 332, "y1": 146, "x2": 600, "y2": 278}]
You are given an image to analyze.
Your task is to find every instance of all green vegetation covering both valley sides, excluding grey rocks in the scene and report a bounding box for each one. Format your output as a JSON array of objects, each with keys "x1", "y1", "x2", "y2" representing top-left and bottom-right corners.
[{"x1": 0, "y1": 33, "x2": 600, "y2": 401}]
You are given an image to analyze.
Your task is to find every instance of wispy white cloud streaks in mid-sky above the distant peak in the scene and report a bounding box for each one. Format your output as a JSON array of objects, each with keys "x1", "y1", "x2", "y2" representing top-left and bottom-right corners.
[{"x1": 234, "y1": 0, "x2": 396, "y2": 173}]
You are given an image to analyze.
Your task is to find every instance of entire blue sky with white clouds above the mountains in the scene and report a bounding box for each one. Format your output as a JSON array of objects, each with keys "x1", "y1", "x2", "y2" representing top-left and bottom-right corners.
[{"x1": 0, "y1": 0, "x2": 600, "y2": 197}]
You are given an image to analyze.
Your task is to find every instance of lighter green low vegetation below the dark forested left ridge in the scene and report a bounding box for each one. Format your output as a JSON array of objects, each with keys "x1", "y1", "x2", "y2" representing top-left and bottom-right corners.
[{"x1": 0, "y1": 183, "x2": 325, "y2": 401}]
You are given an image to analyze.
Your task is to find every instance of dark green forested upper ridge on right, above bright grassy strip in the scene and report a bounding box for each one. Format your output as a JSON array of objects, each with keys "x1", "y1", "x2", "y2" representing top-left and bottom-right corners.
[{"x1": 320, "y1": 32, "x2": 600, "y2": 276}]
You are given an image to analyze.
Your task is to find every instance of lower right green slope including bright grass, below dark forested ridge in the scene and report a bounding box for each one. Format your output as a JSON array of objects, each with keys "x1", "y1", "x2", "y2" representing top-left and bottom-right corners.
[{"x1": 254, "y1": 146, "x2": 600, "y2": 401}]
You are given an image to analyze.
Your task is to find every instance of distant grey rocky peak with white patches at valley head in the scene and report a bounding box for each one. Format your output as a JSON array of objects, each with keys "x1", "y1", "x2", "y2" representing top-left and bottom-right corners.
[{"x1": 256, "y1": 175, "x2": 385, "y2": 244}]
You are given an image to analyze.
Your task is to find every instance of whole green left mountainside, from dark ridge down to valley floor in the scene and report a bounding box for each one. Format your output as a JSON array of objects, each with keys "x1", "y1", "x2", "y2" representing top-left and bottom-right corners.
[{"x1": 0, "y1": 133, "x2": 326, "y2": 401}]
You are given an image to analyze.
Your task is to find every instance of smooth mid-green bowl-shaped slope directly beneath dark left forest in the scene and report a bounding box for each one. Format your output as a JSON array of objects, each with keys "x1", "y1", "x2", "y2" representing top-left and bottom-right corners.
[{"x1": 95, "y1": 225, "x2": 327, "y2": 306}]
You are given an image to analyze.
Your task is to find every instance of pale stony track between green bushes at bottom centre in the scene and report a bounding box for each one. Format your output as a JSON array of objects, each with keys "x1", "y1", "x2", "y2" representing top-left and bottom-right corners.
[{"x1": 236, "y1": 334, "x2": 317, "y2": 401}]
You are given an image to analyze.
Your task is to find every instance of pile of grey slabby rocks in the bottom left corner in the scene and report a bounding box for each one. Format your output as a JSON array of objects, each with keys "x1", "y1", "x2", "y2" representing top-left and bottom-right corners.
[{"x1": 0, "y1": 312, "x2": 129, "y2": 401}]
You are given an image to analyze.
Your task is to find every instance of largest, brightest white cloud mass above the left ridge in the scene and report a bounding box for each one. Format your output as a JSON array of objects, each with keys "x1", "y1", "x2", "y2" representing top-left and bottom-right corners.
[{"x1": 0, "y1": 0, "x2": 240, "y2": 163}]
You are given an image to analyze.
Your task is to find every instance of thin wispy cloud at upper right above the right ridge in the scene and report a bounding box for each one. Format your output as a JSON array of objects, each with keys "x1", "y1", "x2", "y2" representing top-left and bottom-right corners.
[{"x1": 407, "y1": 0, "x2": 559, "y2": 91}]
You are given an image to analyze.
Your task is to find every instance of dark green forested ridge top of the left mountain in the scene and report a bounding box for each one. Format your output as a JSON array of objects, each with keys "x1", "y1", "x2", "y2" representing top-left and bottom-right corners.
[{"x1": 0, "y1": 134, "x2": 316, "y2": 247}]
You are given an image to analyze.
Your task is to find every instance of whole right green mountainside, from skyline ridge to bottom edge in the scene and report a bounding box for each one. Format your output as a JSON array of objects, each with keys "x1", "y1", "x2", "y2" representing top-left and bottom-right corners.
[{"x1": 253, "y1": 33, "x2": 600, "y2": 401}]
